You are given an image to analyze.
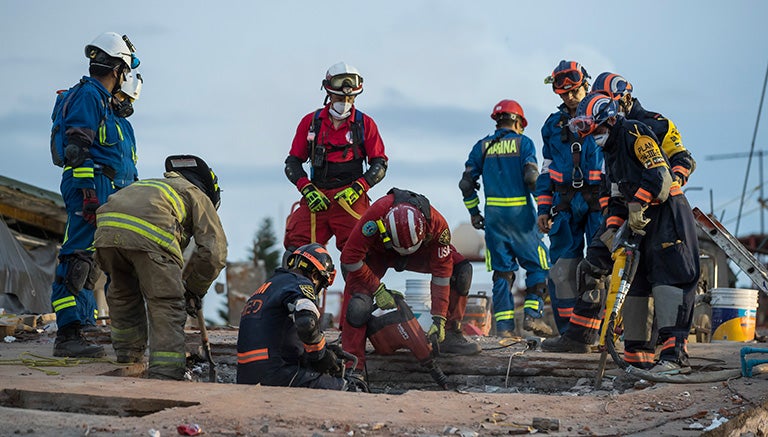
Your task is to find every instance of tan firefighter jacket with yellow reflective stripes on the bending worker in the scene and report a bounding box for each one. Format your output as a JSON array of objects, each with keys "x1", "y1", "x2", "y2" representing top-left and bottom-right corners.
[{"x1": 94, "y1": 172, "x2": 227, "y2": 296}]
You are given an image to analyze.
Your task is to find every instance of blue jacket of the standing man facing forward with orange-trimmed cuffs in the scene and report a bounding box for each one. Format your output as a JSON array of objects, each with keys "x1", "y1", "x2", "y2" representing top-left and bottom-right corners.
[{"x1": 536, "y1": 104, "x2": 604, "y2": 215}]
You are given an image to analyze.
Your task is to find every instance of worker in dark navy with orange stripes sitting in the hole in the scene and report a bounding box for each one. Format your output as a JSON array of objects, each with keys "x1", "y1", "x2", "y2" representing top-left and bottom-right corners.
[{"x1": 237, "y1": 243, "x2": 345, "y2": 390}]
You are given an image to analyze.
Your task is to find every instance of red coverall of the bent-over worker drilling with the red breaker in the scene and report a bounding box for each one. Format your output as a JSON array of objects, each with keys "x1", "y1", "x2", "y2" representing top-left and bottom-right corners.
[{"x1": 341, "y1": 194, "x2": 467, "y2": 369}]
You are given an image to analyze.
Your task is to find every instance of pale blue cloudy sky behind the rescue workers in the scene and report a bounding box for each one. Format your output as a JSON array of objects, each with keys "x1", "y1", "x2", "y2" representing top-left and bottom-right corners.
[{"x1": 0, "y1": 0, "x2": 768, "y2": 316}]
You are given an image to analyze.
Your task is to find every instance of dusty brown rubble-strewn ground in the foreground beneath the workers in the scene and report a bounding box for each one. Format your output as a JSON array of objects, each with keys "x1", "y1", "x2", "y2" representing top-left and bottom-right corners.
[{"x1": 0, "y1": 331, "x2": 768, "y2": 436}]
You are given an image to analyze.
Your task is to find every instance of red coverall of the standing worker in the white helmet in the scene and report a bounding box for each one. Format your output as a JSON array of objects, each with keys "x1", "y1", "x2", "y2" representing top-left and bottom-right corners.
[{"x1": 283, "y1": 104, "x2": 387, "y2": 251}]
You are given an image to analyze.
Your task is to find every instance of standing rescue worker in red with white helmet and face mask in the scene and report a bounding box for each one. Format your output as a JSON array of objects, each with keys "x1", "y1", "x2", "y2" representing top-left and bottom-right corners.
[{"x1": 283, "y1": 62, "x2": 387, "y2": 266}]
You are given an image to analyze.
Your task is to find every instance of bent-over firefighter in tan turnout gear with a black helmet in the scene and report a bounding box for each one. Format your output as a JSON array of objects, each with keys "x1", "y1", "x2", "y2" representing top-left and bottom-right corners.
[{"x1": 94, "y1": 155, "x2": 227, "y2": 380}]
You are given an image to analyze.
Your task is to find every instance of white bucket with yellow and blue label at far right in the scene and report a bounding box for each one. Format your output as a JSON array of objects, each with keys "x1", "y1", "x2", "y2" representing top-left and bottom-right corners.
[{"x1": 712, "y1": 288, "x2": 758, "y2": 341}]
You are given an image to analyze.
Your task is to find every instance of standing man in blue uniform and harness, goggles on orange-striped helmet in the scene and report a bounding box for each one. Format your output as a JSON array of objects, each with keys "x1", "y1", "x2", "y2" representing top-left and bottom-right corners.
[{"x1": 536, "y1": 61, "x2": 607, "y2": 333}]
